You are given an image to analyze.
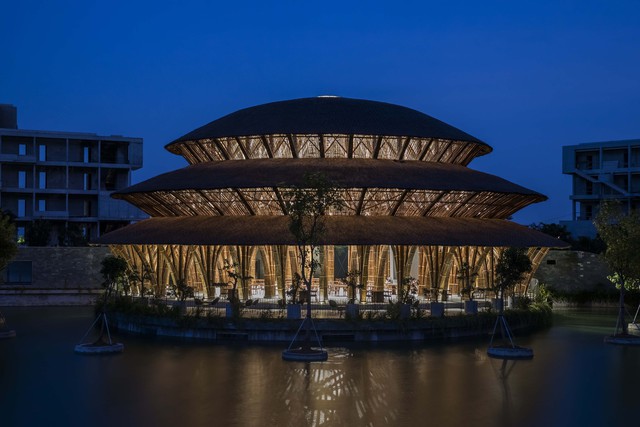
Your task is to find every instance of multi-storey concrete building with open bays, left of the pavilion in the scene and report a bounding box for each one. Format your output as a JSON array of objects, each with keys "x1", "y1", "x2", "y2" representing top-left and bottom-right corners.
[{"x1": 0, "y1": 104, "x2": 147, "y2": 245}]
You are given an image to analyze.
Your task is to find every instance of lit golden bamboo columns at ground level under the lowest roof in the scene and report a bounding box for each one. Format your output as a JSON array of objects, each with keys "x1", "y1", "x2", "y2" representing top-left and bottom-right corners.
[{"x1": 110, "y1": 245, "x2": 548, "y2": 301}]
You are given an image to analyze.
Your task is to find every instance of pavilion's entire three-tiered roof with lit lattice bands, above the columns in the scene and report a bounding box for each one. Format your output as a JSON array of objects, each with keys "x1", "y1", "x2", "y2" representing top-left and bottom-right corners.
[{"x1": 95, "y1": 97, "x2": 559, "y2": 247}]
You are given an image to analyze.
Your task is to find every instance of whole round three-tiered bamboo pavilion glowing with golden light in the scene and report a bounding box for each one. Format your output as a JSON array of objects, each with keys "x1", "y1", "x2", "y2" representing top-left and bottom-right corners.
[{"x1": 97, "y1": 97, "x2": 565, "y2": 302}]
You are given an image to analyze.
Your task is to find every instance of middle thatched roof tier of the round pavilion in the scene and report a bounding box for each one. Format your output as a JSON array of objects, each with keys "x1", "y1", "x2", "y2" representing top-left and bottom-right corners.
[{"x1": 114, "y1": 158, "x2": 546, "y2": 197}]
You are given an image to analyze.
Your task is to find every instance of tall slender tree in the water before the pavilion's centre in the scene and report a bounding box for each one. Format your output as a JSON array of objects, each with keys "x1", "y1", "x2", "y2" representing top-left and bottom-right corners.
[{"x1": 284, "y1": 173, "x2": 341, "y2": 349}]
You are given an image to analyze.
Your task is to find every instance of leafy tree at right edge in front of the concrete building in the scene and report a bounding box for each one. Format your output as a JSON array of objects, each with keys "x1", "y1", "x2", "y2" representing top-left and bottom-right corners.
[{"x1": 594, "y1": 202, "x2": 640, "y2": 335}]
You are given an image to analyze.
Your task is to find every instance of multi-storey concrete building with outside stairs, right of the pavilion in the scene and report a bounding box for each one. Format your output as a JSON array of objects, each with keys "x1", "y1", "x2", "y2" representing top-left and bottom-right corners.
[{"x1": 560, "y1": 139, "x2": 640, "y2": 237}]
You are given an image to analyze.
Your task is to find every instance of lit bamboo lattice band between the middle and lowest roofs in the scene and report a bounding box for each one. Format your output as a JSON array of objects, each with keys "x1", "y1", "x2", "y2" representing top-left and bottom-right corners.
[{"x1": 120, "y1": 187, "x2": 537, "y2": 218}]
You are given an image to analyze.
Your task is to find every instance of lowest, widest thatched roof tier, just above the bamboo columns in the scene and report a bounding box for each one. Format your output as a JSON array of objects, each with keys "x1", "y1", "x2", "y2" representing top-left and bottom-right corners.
[{"x1": 94, "y1": 216, "x2": 567, "y2": 248}]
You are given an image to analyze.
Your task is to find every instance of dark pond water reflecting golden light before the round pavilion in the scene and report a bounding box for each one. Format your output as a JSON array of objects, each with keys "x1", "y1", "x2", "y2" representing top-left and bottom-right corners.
[{"x1": 0, "y1": 308, "x2": 640, "y2": 427}]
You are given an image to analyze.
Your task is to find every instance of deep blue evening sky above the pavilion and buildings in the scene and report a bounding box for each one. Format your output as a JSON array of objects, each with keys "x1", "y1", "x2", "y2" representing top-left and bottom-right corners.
[{"x1": 0, "y1": 0, "x2": 640, "y2": 224}]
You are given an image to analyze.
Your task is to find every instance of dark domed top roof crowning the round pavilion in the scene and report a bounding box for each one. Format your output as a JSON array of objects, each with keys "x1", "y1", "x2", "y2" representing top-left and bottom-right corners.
[{"x1": 167, "y1": 96, "x2": 491, "y2": 152}]
